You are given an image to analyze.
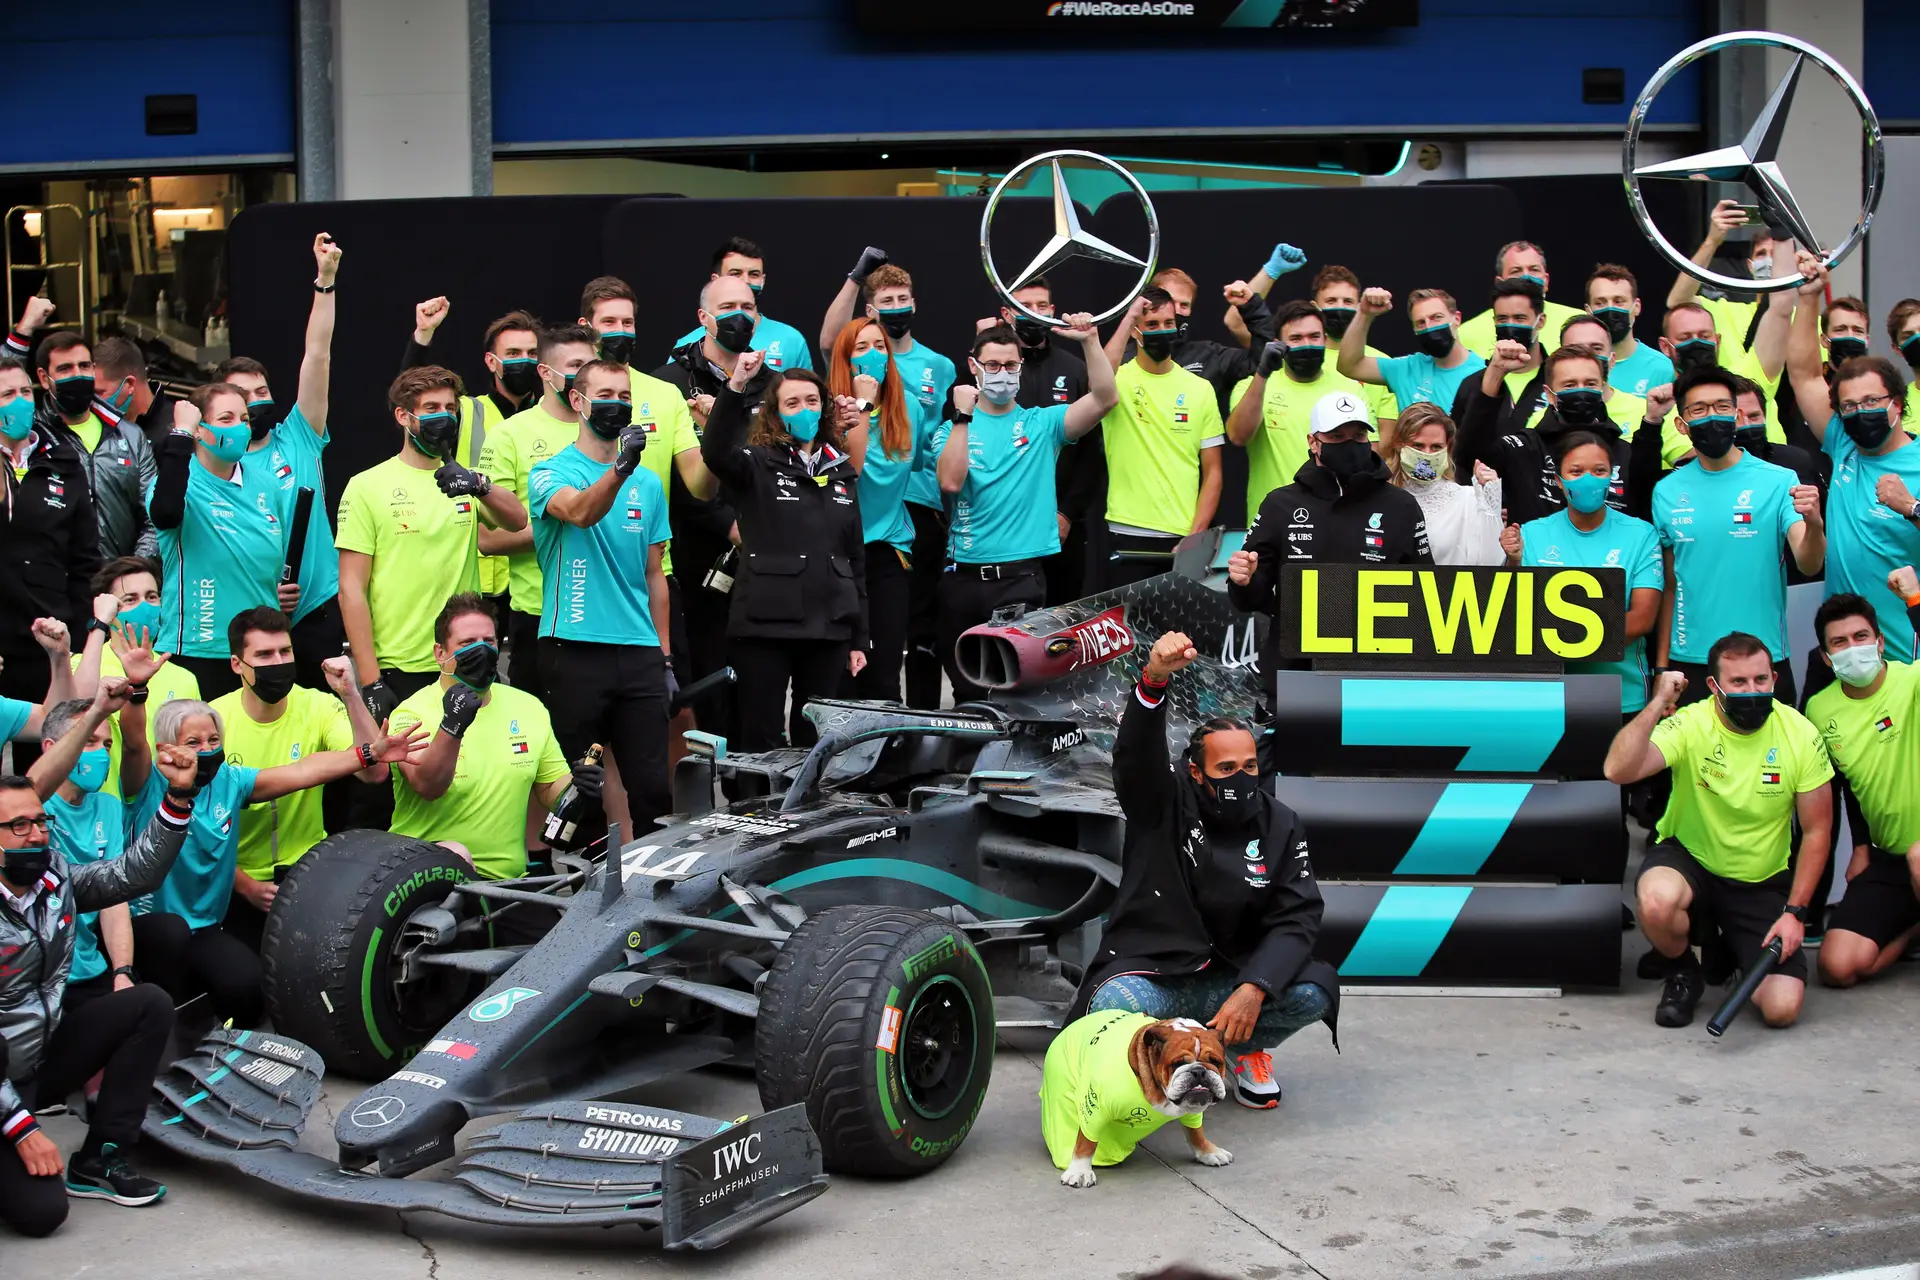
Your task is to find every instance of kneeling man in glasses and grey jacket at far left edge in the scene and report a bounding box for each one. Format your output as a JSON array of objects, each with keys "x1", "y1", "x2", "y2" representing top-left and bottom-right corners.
[{"x1": 0, "y1": 694, "x2": 198, "y2": 1236}]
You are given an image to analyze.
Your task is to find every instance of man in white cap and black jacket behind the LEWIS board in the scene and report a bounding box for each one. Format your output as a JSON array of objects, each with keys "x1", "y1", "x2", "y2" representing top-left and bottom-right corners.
[{"x1": 1227, "y1": 391, "x2": 1434, "y2": 672}]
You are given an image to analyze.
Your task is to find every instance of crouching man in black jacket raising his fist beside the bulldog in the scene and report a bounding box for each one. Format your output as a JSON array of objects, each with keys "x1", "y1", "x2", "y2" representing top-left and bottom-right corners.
[{"x1": 1073, "y1": 631, "x2": 1340, "y2": 1111}]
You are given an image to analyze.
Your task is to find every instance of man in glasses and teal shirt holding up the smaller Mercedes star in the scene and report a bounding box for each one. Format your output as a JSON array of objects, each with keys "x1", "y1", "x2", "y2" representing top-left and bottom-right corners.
[{"x1": 931, "y1": 313, "x2": 1119, "y2": 702}]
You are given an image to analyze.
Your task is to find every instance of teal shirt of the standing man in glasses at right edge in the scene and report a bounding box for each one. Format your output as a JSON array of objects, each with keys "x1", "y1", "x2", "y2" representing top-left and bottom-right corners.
[{"x1": 1820, "y1": 420, "x2": 1920, "y2": 662}]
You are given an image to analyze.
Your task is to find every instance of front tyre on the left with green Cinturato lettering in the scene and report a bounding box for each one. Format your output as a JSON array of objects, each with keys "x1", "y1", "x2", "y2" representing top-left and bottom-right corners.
[{"x1": 261, "y1": 831, "x2": 472, "y2": 1080}]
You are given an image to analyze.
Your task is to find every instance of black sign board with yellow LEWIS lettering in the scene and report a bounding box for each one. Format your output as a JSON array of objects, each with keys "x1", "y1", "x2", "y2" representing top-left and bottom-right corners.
[{"x1": 1275, "y1": 564, "x2": 1628, "y2": 662}]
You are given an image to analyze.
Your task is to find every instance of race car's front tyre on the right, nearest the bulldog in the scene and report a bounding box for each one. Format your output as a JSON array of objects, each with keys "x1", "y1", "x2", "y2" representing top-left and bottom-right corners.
[{"x1": 755, "y1": 906, "x2": 995, "y2": 1176}]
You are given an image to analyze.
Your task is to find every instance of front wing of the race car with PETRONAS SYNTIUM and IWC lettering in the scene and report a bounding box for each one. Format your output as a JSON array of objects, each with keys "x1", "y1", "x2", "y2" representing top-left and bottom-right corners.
[{"x1": 144, "y1": 1029, "x2": 828, "y2": 1249}]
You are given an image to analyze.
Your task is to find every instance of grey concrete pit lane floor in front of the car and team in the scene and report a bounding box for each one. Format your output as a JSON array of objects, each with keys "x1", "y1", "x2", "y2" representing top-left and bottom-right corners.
[{"x1": 15, "y1": 844, "x2": 1920, "y2": 1280}]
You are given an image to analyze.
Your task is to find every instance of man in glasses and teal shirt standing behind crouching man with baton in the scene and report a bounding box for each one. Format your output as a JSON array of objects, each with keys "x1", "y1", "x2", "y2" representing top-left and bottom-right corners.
[{"x1": 1653, "y1": 365, "x2": 1826, "y2": 706}]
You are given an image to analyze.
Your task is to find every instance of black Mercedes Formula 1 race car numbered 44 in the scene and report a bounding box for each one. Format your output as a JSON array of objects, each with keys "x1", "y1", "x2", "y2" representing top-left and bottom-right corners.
[{"x1": 146, "y1": 535, "x2": 1258, "y2": 1249}]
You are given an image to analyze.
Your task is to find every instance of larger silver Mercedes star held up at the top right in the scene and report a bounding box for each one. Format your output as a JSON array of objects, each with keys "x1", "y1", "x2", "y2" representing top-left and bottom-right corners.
[{"x1": 1622, "y1": 31, "x2": 1885, "y2": 294}]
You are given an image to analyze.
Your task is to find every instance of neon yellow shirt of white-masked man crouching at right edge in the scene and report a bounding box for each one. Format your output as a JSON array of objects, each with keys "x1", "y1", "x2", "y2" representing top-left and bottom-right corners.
[{"x1": 1807, "y1": 662, "x2": 1920, "y2": 856}]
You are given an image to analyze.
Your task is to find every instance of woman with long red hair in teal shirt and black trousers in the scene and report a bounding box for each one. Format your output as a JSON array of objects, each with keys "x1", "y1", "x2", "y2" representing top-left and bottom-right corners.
[{"x1": 826, "y1": 319, "x2": 933, "y2": 702}]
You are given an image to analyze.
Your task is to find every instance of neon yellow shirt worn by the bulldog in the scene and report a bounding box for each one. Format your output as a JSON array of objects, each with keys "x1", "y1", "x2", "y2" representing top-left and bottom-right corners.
[{"x1": 1041, "y1": 1009, "x2": 1204, "y2": 1169}]
